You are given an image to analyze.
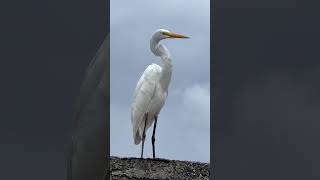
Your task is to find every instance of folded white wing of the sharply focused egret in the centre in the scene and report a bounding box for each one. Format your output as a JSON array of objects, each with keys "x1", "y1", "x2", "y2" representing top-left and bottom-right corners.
[{"x1": 131, "y1": 64, "x2": 161, "y2": 144}]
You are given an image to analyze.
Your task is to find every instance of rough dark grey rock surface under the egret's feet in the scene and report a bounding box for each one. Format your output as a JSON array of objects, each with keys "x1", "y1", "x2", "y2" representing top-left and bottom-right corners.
[{"x1": 110, "y1": 157, "x2": 210, "y2": 180}]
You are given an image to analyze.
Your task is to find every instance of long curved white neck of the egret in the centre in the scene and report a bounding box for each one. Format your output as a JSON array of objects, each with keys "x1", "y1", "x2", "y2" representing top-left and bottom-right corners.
[{"x1": 150, "y1": 38, "x2": 172, "y2": 91}]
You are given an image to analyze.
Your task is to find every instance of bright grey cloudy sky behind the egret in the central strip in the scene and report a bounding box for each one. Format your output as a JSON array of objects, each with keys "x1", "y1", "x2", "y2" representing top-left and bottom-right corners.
[{"x1": 110, "y1": 0, "x2": 210, "y2": 162}]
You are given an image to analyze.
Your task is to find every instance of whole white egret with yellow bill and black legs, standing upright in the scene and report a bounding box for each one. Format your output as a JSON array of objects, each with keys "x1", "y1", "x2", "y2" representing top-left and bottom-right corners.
[{"x1": 131, "y1": 29, "x2": 189, "y2": 158}]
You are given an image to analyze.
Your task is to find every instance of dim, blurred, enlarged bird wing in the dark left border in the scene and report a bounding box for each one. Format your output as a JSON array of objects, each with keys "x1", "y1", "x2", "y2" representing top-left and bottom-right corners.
[{"x1": 67, "y1": 36, "x2": 109, "y2": 180}]
